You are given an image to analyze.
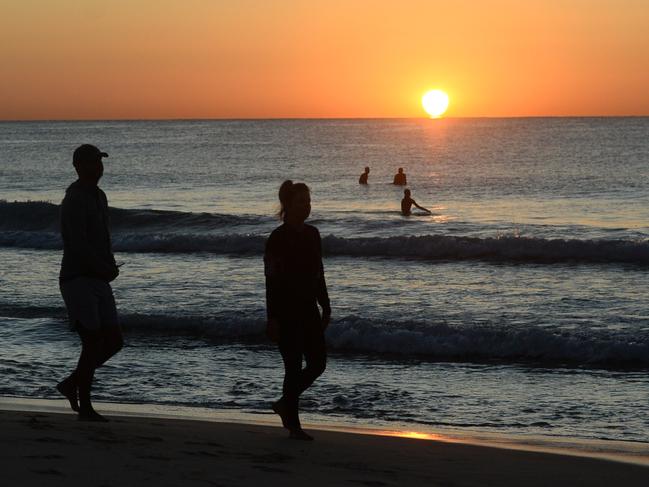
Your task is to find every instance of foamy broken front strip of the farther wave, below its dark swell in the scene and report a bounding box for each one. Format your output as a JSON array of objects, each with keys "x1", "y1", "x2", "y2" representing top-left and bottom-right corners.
[{"x1": 0, "y1": 231, "x2": 649, "y2": 266}]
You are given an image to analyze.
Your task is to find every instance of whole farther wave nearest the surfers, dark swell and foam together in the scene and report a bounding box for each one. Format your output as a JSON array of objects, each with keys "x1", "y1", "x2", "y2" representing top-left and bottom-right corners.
[{"x1": 0, "y1": 202, "x2": 649, "y2": 266}]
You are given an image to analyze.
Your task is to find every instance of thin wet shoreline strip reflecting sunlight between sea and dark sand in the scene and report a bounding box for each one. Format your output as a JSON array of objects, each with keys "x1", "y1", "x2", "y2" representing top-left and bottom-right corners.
[{"x1": 0, "y1": 396, "x2": 649, "y2": 468}]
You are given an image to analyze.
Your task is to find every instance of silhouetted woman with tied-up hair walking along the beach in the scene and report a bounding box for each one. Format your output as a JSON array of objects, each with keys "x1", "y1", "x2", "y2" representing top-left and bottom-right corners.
[{"x1": 264, "y1": 181, "x2": 331, "y2": 440}]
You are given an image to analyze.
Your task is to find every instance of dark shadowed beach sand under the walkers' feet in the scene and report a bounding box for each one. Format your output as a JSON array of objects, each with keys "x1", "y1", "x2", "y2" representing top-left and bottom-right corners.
[{"x1": 0, "y1": 411, "x2": 649, "y2": 487}]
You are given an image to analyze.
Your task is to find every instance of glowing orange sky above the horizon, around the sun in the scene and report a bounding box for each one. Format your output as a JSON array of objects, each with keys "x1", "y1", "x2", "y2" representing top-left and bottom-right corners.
[{"x1": 0, "y1": 0, "x2": 649, "y2": 120}]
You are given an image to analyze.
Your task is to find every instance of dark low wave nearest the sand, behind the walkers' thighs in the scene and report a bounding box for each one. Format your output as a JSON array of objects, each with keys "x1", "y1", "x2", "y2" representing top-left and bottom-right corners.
[{"x1": 6, "y1": 305, "x2": 649, "y2": 368}]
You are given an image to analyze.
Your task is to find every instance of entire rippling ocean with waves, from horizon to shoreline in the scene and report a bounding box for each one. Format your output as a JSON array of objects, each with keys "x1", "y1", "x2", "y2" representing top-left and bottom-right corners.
[{"x1": 0, "y1": 118, "x2": 649, "y2": 443}]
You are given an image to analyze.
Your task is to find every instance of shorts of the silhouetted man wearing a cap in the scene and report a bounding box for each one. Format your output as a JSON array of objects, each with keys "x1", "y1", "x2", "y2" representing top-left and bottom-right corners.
[{"x1": 59, "y1": 277, "x2": 119, "y2": 331}]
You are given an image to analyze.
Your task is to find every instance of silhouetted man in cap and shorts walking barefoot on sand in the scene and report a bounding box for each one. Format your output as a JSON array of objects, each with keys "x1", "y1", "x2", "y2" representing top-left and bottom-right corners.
[{"x1": 56, "y1": 144, "x2": 123, "y2": 422}]
